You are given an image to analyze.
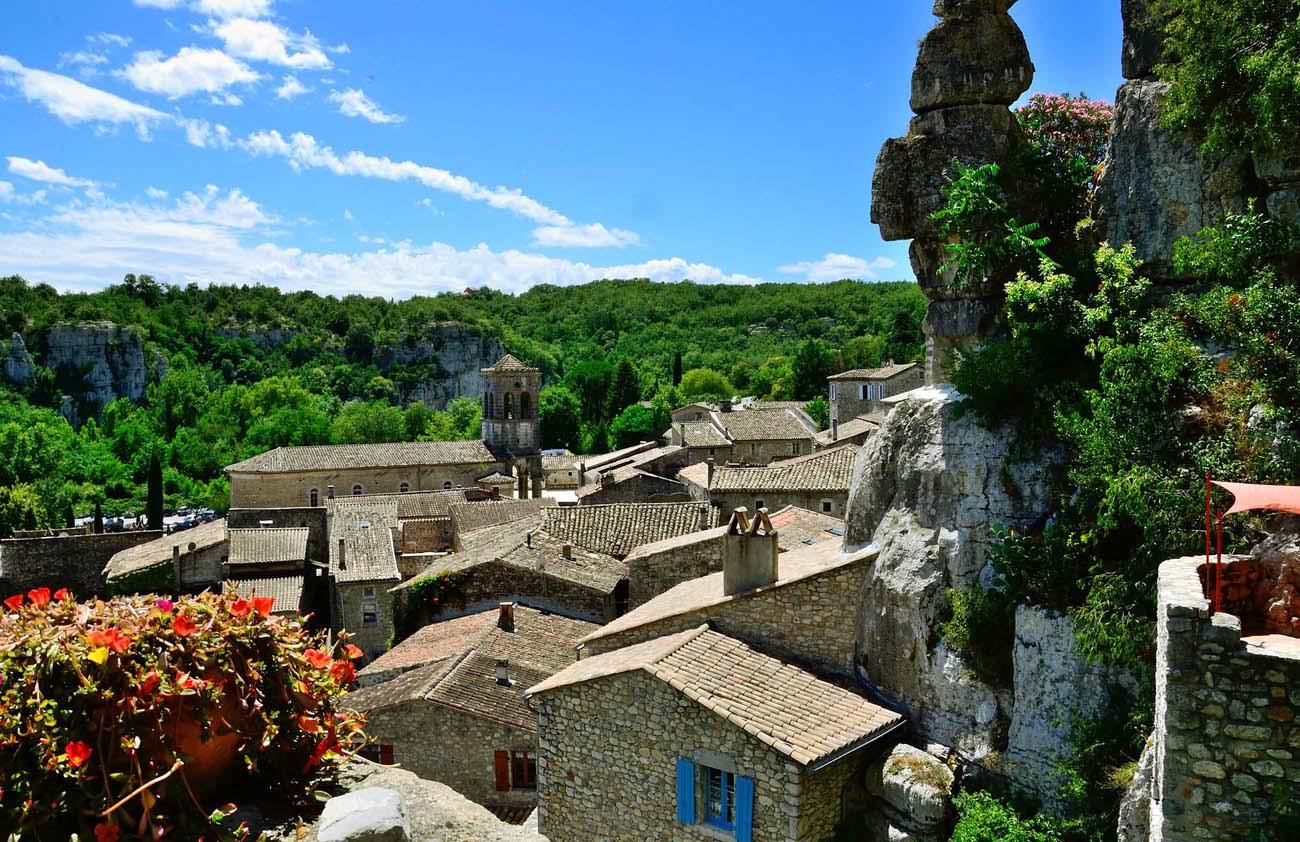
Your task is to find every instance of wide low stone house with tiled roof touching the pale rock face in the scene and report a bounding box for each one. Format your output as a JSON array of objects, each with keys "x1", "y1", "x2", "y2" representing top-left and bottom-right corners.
[{"x1": 685, "y1": 444, "x2": 858, "y2": 518}]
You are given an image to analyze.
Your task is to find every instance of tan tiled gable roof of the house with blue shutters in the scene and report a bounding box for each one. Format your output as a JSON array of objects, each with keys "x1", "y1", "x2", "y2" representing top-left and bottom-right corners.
[{"x1": 528, "y1": 626, "x2": 904, "y2": 765}]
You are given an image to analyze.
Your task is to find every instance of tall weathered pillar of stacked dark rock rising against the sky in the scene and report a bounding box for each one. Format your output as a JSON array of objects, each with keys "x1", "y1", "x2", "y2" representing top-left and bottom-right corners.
[{"x1": 871, "y1": 0, "x2": 1034, "y2": 383}]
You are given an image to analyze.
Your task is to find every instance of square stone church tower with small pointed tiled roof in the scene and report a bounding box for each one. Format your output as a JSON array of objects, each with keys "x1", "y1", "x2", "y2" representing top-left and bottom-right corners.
[{"x1": 482, "y1": 353, "x2": 542, "y2": 498}]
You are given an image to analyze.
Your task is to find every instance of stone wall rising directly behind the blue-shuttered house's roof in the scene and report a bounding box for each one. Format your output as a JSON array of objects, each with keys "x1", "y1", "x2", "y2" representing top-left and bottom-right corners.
[{"x1": 584, "y1": 555, "x2": 874, "y2": 674}]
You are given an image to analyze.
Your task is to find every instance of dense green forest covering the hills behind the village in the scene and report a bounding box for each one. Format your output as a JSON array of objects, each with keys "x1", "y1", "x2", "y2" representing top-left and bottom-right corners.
[{"x1": 0, "y1": 274, "x2": 924, "y2": 535}]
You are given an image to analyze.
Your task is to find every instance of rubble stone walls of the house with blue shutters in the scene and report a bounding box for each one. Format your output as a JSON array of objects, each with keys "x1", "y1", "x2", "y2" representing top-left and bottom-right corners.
[{"x1": 532, "y1": 670, "x2": 866, "y2": 842}]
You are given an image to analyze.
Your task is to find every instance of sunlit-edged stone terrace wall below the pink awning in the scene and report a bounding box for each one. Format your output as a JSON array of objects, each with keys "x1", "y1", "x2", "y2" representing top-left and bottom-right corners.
[{"x1": 1151, "y1": 557, "x2": 1300, "y2": 842}]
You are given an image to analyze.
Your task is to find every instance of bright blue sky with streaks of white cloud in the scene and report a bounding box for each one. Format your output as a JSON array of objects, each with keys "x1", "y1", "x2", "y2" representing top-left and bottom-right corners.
[{"x1": 0, "y1": 0, "x2": 1121, "y2": 298}]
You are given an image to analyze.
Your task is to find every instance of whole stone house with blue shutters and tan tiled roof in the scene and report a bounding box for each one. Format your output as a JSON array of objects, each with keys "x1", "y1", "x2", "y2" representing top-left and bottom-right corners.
[{"x1": 528, "y1": 625, "x2": 905, "y2": 842}]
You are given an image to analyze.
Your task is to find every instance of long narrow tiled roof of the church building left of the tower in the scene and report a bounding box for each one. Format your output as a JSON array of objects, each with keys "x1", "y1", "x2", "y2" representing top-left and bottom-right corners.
[{"x1": 226, "y1": 440, "x2": 497, "y2": 473}]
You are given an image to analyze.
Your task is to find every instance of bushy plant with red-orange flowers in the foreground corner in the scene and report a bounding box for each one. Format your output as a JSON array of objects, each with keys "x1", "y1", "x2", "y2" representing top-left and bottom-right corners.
[{"x1": 0, "y1": 587, "x2": 361, "y2": 842}]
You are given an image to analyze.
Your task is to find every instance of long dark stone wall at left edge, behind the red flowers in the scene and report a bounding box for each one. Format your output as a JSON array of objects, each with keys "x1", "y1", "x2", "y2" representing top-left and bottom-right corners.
[{"x1": 0, "y1": 530, "x2": 163, "y2": 598}]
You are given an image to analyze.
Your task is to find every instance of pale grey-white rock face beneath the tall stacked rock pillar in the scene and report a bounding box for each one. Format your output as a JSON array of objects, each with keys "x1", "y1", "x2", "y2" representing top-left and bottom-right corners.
[{"x1": 845, "y1": 387, "x2": 1052, "y2": 760}]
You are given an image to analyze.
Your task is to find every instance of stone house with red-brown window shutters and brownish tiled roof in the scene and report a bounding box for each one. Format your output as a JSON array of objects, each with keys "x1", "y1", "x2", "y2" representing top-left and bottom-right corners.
[{"x1": 341, "y1": 604, "x2": 595, "y2": 810}]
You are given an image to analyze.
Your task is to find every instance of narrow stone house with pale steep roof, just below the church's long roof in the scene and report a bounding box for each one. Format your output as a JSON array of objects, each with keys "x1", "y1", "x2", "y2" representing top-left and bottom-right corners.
[{"x1": 329, "y1": 498, "x2": 402, "y2": 659}]
